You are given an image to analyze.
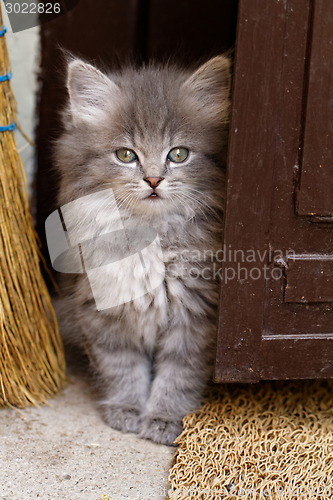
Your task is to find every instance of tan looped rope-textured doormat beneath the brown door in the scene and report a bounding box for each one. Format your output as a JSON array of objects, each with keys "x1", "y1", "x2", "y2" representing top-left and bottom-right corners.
[{"x1": 169, "y1": 381, "x2": 333, "y2": 500}]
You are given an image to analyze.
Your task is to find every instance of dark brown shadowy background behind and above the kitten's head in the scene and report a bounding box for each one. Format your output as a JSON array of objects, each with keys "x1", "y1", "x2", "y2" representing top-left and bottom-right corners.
[{"x1": 35, "y1": 0, "x2": 238, "y2": 278}]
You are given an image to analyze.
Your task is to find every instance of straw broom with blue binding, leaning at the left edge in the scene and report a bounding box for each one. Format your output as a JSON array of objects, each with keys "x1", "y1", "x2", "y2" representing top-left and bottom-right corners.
[{"x1": 0, "y1": 5, "x2": 65, "y2": 408}]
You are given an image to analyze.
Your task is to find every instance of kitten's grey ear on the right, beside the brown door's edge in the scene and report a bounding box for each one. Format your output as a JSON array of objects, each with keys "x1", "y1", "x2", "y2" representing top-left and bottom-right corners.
[{"x1": 184, "y1": 55, "x2": 231, "y2": 122}]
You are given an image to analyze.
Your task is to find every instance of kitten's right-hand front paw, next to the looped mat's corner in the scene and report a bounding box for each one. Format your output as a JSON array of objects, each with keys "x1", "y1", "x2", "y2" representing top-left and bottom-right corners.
[{"x1": 140, "y1": 417, "x2": 183, "y2": 446}]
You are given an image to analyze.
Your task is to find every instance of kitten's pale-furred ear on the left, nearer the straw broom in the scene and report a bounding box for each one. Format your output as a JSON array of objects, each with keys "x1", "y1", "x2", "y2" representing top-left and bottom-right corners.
[{"x1": 67, "y1": 59, "x2": 119, "y2": 125}]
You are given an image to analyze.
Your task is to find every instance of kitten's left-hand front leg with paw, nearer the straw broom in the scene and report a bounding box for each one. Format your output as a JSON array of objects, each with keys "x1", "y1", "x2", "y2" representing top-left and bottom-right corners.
[{"x1": 93, "y1": 346, "x2": 151, "y2": 432}]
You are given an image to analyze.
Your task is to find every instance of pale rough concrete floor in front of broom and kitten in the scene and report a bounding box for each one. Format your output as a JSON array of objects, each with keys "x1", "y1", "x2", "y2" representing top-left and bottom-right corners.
[{"x1": 0, "y1": 373, "x2": 175, "y2": 500}]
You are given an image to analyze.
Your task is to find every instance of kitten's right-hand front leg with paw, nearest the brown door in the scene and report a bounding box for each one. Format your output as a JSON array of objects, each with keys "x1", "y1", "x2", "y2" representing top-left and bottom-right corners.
[{"x1": 140, "y1": 318, "x2": 214, "y2": 445}]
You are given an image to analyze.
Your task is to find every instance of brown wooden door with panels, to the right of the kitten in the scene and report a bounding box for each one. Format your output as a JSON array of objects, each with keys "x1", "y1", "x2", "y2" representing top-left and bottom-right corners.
[{"x1": 216, "y1": 0, "x2": 333, "y2": 382}]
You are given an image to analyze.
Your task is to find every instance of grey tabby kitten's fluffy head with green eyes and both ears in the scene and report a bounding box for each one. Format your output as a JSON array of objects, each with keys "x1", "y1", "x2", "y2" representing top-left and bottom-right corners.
[{"x1": 57, "y1": 56, "x2": 230, "y2": 222}]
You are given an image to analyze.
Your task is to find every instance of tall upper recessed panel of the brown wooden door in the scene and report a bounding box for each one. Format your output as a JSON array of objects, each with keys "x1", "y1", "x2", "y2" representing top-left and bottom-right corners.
[{"x1": 297, "y1": 0, "x2": 333, "y2": 217}]
